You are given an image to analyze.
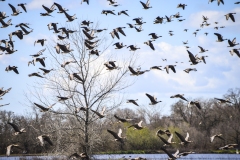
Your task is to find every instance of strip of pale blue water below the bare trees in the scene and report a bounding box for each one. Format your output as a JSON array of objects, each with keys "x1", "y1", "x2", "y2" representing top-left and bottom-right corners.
[{"x1": 0, "y1": 154, "x2": 240, "y2": 160}]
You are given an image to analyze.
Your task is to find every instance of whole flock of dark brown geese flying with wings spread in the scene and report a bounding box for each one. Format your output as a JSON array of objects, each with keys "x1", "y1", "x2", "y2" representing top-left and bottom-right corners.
[{"x1": 0, "y1": 0, "x2": 240, "y2": 160}]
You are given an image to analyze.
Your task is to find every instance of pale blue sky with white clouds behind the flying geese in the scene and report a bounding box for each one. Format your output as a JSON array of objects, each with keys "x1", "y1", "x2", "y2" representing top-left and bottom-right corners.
[{"x1": 0, "y1": 0, "x2": 240, "y2": 115}]
